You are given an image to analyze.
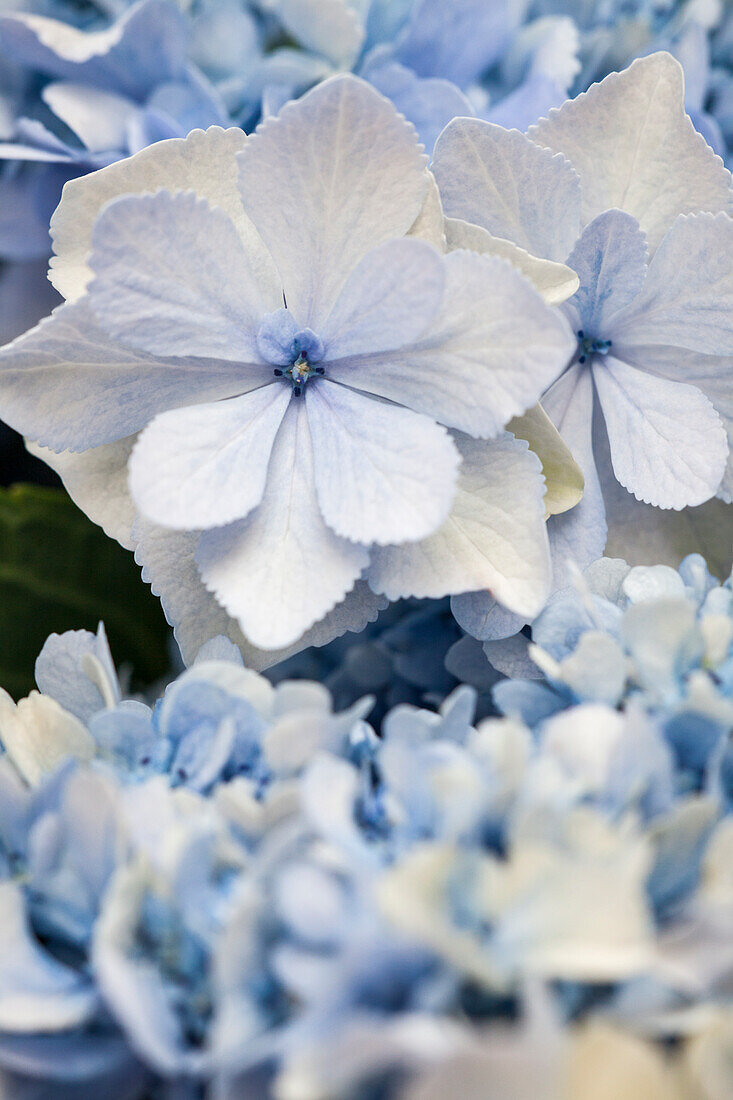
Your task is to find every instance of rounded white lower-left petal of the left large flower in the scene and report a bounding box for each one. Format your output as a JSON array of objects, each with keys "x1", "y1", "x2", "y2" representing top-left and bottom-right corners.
[{"x1": 130, "y1": 383, "x2": 293, "y2": 531}]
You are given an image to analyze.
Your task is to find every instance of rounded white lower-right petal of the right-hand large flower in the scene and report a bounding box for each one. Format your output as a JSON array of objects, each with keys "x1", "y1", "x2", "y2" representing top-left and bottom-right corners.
[{"x1": 593, "y1": 355, "x2": 727, "y2": 508}]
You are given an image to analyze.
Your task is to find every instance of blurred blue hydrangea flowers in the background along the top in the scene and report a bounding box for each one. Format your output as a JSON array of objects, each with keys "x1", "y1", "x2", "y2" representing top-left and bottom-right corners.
[{"x1": 0, "y1": 0, "x2": 733, "y2": 341}]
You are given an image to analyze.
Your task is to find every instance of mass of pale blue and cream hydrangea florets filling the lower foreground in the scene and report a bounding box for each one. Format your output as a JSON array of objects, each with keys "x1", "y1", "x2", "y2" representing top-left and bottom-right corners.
[{"x1": 0, "y1": 598, "x2": 733, "y2": 1100}]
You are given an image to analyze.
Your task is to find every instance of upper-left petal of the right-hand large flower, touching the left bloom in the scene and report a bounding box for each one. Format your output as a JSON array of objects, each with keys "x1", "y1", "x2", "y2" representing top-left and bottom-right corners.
[{"x1": 433, "y1": 119, "x2": 580, "y2": 263}]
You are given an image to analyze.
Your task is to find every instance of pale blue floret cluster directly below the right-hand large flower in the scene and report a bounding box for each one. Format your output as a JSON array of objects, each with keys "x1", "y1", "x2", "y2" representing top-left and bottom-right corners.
[{"x1": 484, "y1": 554, "x2": 733, "y2": 803}]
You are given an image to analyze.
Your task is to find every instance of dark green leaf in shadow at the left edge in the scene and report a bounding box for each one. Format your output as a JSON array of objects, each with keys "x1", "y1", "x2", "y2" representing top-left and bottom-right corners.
[{"x1": 0, "y1": 485, "x2": 168, "y2": 697}]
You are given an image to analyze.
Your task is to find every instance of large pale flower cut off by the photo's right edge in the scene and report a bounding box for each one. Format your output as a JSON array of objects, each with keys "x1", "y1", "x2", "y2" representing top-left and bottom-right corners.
[{"x1": 433, "y1": 53, "x2": 733, "y2": 602}]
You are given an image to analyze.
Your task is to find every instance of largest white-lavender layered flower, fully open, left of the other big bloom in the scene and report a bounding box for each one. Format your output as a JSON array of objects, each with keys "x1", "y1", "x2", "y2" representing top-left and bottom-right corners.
[{"x1": 0, "y1": 77, "x2": 572, "y2": 656}]
